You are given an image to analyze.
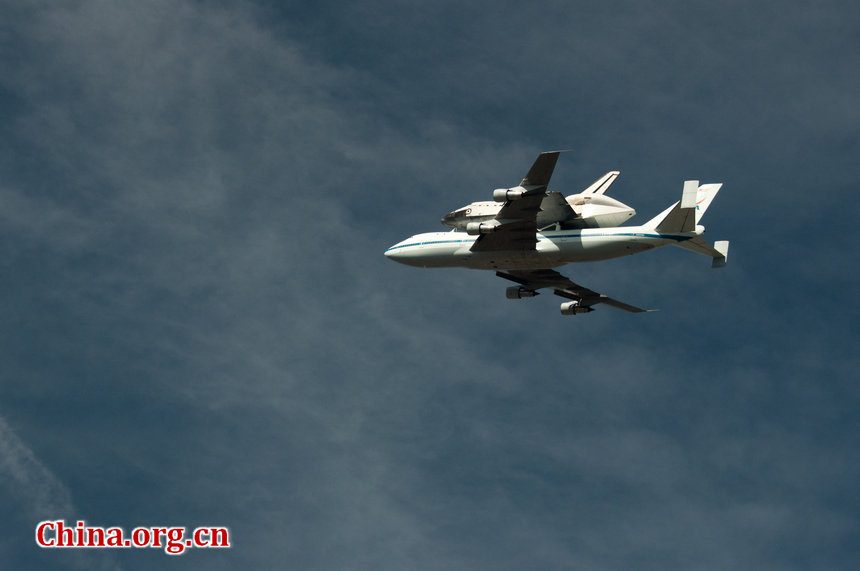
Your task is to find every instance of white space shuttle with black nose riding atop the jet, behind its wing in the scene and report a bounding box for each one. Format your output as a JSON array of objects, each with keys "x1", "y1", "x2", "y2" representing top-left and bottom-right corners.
[{"x1": 441, "y1": 171, "x2": 636, "y2": 231}]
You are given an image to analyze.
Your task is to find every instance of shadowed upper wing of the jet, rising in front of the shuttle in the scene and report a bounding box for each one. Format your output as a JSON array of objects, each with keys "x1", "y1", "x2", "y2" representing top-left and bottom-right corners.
[{"x1": 471, "y1": 151, "x2": 561, "y2": 252}]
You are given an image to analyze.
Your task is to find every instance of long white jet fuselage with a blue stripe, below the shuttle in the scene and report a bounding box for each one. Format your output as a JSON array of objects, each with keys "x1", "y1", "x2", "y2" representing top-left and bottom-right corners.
[{"x1": 385, "y1": 226, "x2": 704, "y2": 270}]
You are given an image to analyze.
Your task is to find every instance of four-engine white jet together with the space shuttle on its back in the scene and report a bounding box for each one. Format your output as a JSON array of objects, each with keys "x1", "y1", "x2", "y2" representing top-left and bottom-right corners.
[{"x1": 385, "y1": 151, "x2": 729, "y2": 315}]
